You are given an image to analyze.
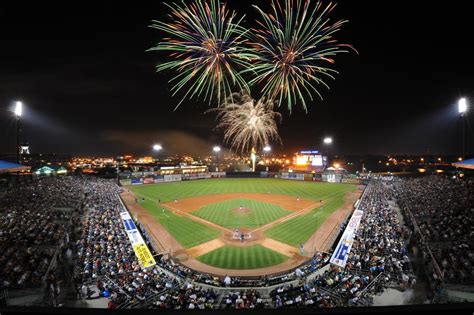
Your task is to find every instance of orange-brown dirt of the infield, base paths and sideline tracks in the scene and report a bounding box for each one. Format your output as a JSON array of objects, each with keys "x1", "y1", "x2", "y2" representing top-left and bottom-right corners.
[{"x1": 121, "y1": 186, "x2": 362, "y2": 277}]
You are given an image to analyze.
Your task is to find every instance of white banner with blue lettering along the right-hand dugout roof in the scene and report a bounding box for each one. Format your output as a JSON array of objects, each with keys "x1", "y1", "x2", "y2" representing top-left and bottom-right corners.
[{"x1": 329, "y1": 210, "x2": 364, "y2": 268}]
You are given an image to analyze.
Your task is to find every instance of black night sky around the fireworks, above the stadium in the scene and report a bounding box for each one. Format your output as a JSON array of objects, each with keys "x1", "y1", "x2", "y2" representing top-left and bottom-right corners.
[{"x1": 0, "y1": 0, "x2": 474, "y2": 155}]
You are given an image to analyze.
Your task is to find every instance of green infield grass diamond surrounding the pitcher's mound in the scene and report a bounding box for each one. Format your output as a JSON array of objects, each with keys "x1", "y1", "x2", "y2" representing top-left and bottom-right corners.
[{"x1": 192, "y1": 198, "x2": 292, "y2": 229}]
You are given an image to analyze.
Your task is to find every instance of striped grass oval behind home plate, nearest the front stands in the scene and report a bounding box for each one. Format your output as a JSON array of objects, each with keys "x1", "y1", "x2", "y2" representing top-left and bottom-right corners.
[{"x1": 196, "y1": 245, "x2": 288, "y2": 269}]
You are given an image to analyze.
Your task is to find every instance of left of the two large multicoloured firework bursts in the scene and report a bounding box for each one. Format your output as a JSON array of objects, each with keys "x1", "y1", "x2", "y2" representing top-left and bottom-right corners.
[{"x1": 148, "y1": 0, "x2": 253, "y2": 109}]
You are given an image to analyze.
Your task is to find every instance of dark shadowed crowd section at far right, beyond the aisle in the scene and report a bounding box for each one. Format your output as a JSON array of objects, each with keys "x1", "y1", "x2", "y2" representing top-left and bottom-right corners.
[{"x1": 394, "y1": 175, "x2": 474, "y2": 296}]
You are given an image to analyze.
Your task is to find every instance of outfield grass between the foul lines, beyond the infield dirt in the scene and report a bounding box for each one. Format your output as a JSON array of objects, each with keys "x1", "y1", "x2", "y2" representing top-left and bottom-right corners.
[{"x1": 128, "y1": 178, "x2": 356, "y2": 202}]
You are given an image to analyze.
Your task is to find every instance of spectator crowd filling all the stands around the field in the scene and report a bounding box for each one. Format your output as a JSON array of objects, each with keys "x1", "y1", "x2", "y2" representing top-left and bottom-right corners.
[{"x1": 4, "y1": 176, "x2": 474, "y2": 310}]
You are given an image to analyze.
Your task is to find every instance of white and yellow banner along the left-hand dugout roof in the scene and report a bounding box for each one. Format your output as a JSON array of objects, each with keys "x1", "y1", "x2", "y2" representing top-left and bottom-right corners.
[{"x1": 120, "y1": 207, "x2": 156, "y2": 268}]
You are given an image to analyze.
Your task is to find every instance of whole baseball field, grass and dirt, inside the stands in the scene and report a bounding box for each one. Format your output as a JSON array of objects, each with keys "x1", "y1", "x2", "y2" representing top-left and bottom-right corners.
[{"x1": 122, "y1": 178, "x2": 361, "y2": 275}]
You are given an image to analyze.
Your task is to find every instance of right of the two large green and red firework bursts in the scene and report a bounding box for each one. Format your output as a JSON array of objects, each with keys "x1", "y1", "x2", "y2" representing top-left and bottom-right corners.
[{"x1": 248, "y1": 0, "x2": 353, "y2": 112}]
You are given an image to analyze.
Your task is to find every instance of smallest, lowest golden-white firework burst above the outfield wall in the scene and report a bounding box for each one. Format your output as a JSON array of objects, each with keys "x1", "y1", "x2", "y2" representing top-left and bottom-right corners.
[{"x1": 207, "y1": 92, "x2": 281, "y2": 153}]
